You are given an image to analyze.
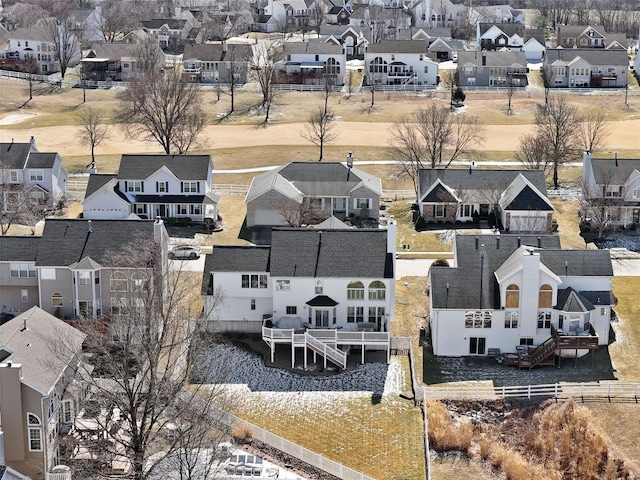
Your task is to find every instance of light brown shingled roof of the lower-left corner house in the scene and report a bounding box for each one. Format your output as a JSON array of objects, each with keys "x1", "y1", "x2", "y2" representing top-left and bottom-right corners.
[{"x1": 0, "y1": 307, "x2": 86, "y2": 395}]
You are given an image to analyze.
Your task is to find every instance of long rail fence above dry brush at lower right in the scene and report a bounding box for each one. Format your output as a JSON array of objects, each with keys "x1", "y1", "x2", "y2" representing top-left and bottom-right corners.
[{"x1": 423, "y1": 382, "x2": 640, "y2": 403}]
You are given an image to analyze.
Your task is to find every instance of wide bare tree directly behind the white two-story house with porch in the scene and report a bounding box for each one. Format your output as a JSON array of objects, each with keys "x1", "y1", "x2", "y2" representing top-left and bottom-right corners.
[{"x1": 115, "y1": 73, "x2": 206, "y2": 154}]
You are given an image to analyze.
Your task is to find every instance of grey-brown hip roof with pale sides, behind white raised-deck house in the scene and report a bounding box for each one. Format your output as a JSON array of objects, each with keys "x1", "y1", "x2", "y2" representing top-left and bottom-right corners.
[{"x1": 245, "y1": 162, "x2": 382, "y2": 202}]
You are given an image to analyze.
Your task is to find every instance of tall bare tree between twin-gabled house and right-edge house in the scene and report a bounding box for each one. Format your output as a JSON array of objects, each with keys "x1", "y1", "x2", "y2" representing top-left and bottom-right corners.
[{"x1": 535, "y1": 95, "x2": 580, "y2": 189}]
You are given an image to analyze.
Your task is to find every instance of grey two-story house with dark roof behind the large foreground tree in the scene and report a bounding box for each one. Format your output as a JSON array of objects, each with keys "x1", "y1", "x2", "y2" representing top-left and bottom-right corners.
[{"x1": 32, "y1": 219, "x2": 168, "y2": 318}]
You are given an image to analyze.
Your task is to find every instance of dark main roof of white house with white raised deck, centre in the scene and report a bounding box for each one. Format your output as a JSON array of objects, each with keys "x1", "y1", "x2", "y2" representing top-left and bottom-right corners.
[{"x1": 271, "y1": 228, "x2": 393, "y2": 278}]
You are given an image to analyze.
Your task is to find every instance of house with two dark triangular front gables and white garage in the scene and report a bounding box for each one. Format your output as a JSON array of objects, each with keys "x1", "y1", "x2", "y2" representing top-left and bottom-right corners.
[{"x1": 418, "y1": 168, "x2": 554, "y2": 233}]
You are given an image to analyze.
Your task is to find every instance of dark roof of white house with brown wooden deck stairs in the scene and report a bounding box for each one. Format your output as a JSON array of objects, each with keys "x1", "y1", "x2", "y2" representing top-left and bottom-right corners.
[{"x1": 430, "y1": 235, "x2": 613, "y2": 309}]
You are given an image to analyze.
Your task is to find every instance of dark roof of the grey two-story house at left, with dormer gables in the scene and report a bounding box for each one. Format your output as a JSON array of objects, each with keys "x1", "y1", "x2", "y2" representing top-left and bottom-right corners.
[{"x1": 36, "y1": 219, "x2": 159, "y2": 267}]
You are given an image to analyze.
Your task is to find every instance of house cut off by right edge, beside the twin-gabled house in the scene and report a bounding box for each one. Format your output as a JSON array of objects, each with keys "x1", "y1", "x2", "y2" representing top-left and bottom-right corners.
[{"x1": 582, "y1": 152, "x2": 640, "y2": 229}]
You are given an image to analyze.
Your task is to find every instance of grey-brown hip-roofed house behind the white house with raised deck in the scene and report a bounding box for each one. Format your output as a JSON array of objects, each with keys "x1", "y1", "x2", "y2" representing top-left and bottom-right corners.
[{"x1": 245, "y1": 162, "x2": 382, "y2": 233}]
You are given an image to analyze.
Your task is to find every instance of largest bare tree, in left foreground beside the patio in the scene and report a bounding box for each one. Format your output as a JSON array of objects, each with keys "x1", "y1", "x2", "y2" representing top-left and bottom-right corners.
[{"x1": 55, "y1": 238, "x2": 228, "y2": 480}]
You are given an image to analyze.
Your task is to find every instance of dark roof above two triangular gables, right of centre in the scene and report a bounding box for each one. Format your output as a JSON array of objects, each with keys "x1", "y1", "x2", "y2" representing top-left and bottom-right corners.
[{"x1": 419, "y1": 168, "x2": 547, "y2": 201}]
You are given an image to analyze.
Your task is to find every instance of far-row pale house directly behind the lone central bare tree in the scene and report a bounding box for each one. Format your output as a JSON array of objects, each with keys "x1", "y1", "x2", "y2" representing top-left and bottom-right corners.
[{"x1": 278, "y1": 41, "x2": 347, "y2": 85}]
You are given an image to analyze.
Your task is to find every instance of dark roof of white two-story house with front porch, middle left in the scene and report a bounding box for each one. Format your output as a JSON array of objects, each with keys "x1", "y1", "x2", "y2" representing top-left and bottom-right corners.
[{"x1": 118, "y1": 154, "x2": 213, "y2": 180}]
